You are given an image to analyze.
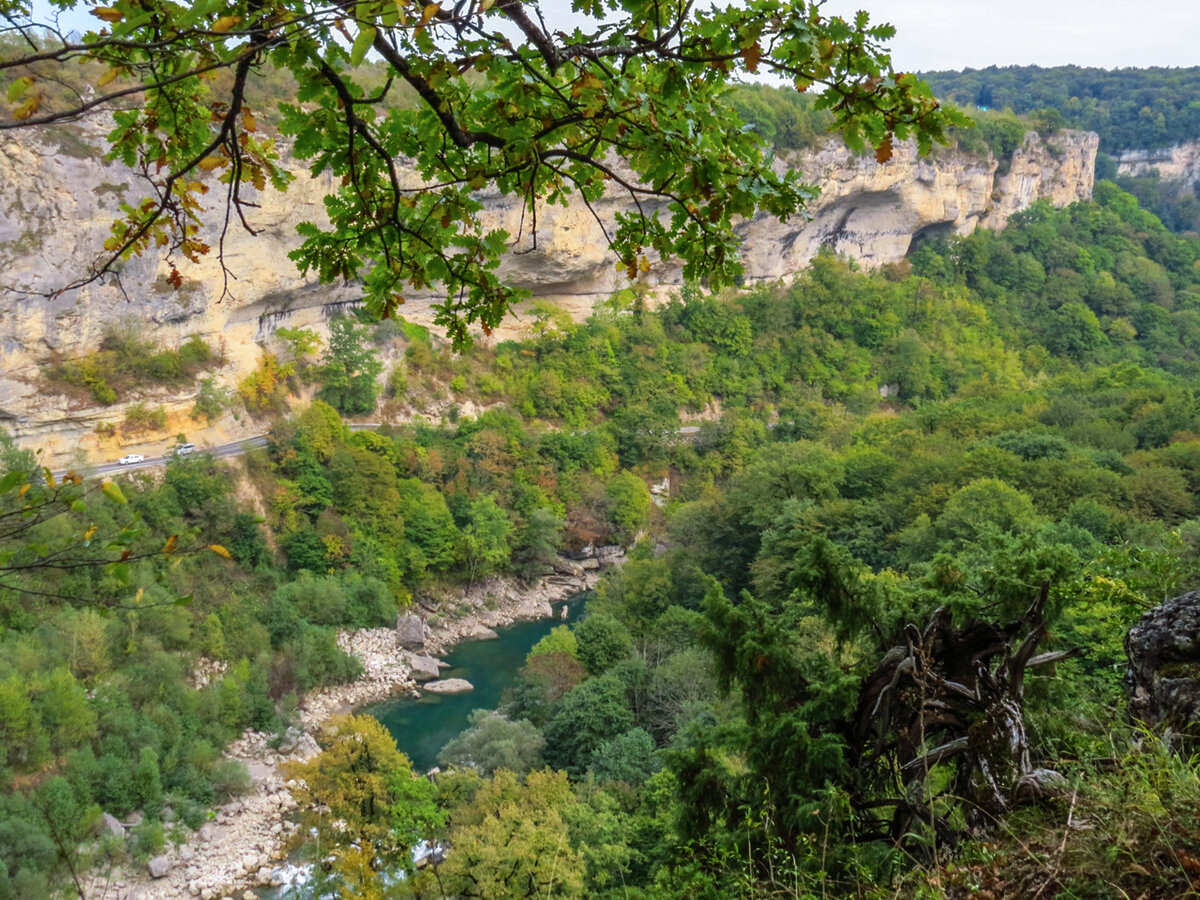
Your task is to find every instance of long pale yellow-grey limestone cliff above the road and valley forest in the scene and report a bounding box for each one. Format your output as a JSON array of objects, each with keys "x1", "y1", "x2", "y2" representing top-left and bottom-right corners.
[{"x1": 0, "y1": 122, "x2": 1097, "y2": 461}]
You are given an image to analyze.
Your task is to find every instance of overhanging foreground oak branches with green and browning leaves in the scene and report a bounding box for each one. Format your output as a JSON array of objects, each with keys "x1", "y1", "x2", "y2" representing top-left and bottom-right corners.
[{"x1": 0, "y1": 0, "x2": 965, "y2": 342}]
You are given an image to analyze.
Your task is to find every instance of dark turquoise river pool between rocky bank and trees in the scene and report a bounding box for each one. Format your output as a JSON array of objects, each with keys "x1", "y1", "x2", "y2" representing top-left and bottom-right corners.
[{"x1": 367, "y1": 594, "x2": 584, "y2": 772}]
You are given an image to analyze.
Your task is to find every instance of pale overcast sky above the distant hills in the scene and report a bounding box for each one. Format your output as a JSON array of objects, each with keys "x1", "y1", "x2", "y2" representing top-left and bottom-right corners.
[{"x1": 34, "y1": 0, "x2": 1200, "y2": 71}]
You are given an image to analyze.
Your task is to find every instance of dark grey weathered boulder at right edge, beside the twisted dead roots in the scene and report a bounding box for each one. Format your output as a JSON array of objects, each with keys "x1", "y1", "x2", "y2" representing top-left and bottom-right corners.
[{"x1": 1126, "y1": 592, "x2": 1200, "y2": 733}]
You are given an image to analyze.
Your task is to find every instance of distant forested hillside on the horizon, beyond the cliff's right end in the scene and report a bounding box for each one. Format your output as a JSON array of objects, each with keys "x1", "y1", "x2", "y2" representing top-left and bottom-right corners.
[{"x1": 920, "y1": 66, "x2": 1200, "y2": 156}]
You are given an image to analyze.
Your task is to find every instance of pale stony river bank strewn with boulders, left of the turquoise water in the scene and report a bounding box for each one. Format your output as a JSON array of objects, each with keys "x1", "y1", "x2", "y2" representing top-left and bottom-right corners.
[{"x1": 85, "y1": 566, "x2": 623, "y2": 900}]
